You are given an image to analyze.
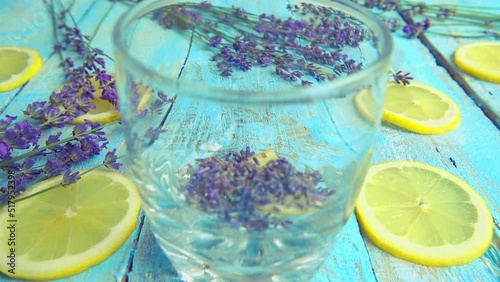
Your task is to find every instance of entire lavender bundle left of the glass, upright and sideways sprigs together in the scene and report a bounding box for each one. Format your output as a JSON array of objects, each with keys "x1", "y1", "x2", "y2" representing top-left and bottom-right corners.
[{"x1": 0, "y1": 1, "x2": 121, "y2": 204}]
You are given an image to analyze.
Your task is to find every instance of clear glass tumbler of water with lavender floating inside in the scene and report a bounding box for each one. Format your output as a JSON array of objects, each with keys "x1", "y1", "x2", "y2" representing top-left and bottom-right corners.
[{"x1": 113, "y1": 0, "x2": 392, "y2": 281}]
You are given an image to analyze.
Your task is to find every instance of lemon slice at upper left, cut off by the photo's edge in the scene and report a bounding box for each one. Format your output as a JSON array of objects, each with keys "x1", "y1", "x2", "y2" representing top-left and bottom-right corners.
[{"x1": 0, "y1": 46, "x2": 43, "y2": 92}]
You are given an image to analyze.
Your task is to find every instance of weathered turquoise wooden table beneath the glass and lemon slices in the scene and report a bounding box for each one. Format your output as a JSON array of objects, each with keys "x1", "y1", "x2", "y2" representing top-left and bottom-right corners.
[{"x1": 0, "y1": 0, "x2": 500, "y2": 281}]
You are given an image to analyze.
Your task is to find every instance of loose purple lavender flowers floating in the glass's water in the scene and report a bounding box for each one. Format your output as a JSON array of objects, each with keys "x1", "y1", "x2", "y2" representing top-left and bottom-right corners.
[{"x1": 184, "y1": 147, "x2": 333, "y2": 231}]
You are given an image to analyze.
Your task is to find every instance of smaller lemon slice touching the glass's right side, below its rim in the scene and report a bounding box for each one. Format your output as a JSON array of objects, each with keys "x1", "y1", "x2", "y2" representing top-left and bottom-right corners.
[{"x1": 383, "y1": 82, "x2": 460, "y2": 134}]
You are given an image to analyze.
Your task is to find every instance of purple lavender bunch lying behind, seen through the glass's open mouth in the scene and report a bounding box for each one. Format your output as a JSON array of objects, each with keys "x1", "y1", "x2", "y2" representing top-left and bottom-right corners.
[{"x1": 153, "y1": 2, "x2": 372, "y2": 85}]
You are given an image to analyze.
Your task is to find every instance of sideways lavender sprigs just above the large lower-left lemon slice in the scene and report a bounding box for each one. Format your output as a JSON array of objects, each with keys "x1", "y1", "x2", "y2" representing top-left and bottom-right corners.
[{"x1": 0, "y1": 117, "x2": 115, "y2": 204}]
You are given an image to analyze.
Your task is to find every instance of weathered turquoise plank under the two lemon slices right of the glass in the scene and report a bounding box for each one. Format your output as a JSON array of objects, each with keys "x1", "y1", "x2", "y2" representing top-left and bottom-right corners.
[{"x1": 366, "y1": 29, "x2": 500, "y2": 281}]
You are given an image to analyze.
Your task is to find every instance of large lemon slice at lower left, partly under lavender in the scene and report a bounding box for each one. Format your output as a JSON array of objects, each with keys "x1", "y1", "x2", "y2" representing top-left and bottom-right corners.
[{"x1": 0, "y1": 170, "x2": 140, "y2": 280}]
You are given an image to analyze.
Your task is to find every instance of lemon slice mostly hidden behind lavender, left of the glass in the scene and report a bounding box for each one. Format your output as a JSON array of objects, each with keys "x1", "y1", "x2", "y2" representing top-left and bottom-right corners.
[{"x1": 73, "y1": 77, "x2": 152, "y2": 123}]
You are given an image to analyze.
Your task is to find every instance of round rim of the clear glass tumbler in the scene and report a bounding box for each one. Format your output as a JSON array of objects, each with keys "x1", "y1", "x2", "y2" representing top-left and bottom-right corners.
[{"x1": 112, "y1": 0, "x2": 394, "y2": 103}]
